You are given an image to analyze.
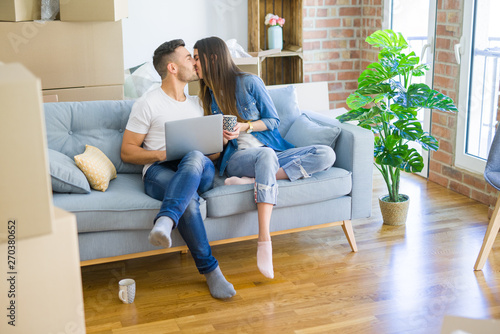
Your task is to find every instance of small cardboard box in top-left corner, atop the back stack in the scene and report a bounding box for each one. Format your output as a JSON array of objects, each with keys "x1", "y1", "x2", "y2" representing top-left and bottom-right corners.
[{"x1": 0, "y1": 0, "x2": 42, "y2": 21}]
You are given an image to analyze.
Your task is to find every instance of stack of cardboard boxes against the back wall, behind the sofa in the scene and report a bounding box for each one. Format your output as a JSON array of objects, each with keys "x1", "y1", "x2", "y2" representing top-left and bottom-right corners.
[{"x1": 0, "y1": 0, "x2": 128, "y2": 101}]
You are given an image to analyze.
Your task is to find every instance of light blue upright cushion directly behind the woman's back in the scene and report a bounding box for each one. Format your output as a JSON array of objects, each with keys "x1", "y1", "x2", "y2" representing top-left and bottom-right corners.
[{"x1": 268, "y1": 86, "x2": 300, "y2": 137}]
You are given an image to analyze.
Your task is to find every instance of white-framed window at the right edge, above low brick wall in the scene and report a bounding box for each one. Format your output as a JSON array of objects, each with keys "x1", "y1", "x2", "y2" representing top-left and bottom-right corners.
[{"x1": 455, "y1": 0, "x2": 500, "y2": 173}]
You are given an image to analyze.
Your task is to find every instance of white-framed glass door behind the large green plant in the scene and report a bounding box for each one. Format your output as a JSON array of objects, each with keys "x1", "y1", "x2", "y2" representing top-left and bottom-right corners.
[{"x1": 384, "y1": 0, "x2": 437, "y2": 177}]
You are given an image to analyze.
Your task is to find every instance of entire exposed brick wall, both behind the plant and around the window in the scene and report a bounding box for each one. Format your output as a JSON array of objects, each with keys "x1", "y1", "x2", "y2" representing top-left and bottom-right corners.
[{"x1": 303, "y1": 0, "x2": 498, "y2": 212}]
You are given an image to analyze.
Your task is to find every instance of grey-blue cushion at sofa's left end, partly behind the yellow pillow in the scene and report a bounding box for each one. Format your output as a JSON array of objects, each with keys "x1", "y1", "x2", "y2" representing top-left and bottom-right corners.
[{"x1": 49, "y1": 149, "x2": 90, "y2": 194}]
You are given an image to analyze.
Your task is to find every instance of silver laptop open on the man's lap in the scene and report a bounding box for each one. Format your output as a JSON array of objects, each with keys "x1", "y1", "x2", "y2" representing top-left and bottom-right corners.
[{"x1": 165, "y1": 114, "x2": 223, "y2": 161}]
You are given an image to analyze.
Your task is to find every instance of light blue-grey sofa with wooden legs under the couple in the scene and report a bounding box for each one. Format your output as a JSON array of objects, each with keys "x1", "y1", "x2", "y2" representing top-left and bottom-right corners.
[{"x1": 44, "y1": 86, "x2": 373, "y2": 263}]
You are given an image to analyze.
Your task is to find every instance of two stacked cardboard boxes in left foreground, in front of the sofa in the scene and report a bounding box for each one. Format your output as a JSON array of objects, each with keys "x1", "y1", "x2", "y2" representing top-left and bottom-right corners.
[{"x1": 0, "y1": 62, "x2": 85, "y2": 334}]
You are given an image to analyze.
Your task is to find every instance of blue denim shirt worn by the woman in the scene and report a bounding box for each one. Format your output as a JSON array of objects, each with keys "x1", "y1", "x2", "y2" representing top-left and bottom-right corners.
[{"x1": 210, "y1": 74, "x2": 294, "y2": 175}]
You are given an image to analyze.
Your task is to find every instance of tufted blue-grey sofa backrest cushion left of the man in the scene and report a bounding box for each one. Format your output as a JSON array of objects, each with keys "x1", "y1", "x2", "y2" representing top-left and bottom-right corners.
[{"x1": 44, "y1": 101, "x2": 143, "y2": 173}]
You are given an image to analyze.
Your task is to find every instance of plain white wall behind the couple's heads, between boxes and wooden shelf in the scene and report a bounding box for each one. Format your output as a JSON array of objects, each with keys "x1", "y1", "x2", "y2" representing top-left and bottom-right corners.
[{"x1": 123, "y1": 0, "x2": 248, "y2": 68}]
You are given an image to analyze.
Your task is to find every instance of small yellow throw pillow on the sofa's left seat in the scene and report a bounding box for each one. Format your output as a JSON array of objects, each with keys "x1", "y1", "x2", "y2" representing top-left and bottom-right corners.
[{"x1": 75, "y1": 145, "x2": 116, "y2": 191}]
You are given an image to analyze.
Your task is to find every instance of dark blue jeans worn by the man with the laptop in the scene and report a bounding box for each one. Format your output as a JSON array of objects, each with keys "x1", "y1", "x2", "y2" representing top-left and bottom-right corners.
[{"x1": 144, "y1": 151, "x2": 219, "y2": 274}]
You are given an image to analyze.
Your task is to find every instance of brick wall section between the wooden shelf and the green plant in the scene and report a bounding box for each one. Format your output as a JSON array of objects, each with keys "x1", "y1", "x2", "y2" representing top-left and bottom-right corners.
[{"x1": 303, "y1": 0, "x2": 382, "y2": 109}]
